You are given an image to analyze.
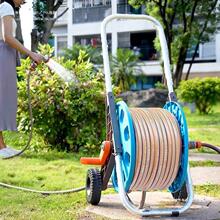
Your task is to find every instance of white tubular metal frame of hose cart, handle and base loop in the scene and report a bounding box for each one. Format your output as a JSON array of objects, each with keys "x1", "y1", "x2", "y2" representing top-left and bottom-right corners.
[{"x1": 101, "y1": 14, "x2": 193, "y2": 216}]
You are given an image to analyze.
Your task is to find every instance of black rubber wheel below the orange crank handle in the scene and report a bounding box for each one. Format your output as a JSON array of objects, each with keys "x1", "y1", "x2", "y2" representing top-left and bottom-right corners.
[{"x1": 86, "y1": 169, "x2": 102, "y2": 205}]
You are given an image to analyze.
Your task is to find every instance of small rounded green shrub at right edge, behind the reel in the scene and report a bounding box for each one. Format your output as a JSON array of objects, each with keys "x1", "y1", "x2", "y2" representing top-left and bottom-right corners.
[{"x1": 177, "y1": 77, "x2": 220, "y2": 114}]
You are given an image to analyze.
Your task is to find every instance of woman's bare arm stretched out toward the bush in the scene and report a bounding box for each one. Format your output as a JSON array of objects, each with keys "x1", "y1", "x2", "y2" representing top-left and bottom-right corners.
[{"x1": 2, "y1": 16, "x2": 44, "y2": 64}]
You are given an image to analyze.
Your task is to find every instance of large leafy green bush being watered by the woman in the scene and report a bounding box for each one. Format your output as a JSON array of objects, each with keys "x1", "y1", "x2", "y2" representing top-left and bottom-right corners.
[{"x1": 18, "y1": 43, "x2": 105, "y2": 151}]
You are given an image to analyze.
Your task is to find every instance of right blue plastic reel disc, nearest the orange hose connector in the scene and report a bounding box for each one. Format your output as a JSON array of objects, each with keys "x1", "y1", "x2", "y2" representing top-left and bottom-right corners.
[{"x1": 164, "y1": 102, "x2": 189, "y2": 193}]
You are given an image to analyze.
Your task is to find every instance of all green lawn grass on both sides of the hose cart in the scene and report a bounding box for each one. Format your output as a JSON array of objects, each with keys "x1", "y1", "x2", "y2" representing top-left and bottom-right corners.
[{"x1": 0, "y1": 105, "x2": 220, "y2": 220}]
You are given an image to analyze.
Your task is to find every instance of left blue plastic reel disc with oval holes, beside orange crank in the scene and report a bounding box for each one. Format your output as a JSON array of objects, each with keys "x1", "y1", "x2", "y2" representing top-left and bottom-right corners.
[{"x1": 112, "y1": 101, "x2": 136, "y2": 192}]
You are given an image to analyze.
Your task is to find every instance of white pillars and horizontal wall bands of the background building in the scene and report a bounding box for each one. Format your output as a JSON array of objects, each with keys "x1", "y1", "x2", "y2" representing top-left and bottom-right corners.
[{"x1": 52, "y1": 0, "x2": 220, "y2": 75}]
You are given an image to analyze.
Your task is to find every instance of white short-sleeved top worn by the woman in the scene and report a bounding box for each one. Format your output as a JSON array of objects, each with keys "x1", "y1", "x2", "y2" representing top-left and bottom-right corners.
[{"x1": 0, "y1": 2, "x2": 17, "y2": 40}]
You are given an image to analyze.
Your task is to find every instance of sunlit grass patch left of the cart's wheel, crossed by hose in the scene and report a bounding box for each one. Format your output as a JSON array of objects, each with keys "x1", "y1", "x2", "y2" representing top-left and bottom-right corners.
[{"x1": 0, "y1": 152, "x2": 87, "y2": 220}]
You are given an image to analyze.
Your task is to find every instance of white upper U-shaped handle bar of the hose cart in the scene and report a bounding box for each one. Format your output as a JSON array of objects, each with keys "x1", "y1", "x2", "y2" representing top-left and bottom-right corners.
[{"x1": 101, "y1": 14, "x2": 173, "y2": 99}]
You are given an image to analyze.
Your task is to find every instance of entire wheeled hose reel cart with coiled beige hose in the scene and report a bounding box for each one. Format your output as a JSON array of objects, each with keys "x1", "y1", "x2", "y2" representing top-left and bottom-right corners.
[{"x1": 81, "y1": 14, "x2": 193, "y2": 216}]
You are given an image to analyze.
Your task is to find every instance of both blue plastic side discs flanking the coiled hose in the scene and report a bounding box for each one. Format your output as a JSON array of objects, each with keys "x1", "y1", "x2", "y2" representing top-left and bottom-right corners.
[{"x1": 112, "y1": 101, "x2": 188, "y2": 193}]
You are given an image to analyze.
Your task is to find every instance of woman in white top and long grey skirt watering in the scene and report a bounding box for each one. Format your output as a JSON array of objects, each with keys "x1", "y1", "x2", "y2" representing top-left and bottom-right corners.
[{"x1": 0, "y1": 0, "x2": 44, "y2": 157}]
